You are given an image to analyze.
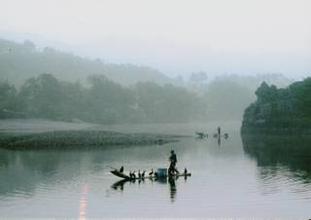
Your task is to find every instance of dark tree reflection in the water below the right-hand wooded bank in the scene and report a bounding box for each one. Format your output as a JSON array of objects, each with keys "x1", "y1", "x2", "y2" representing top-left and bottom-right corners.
[{"x1": 242, "y1": 136, "x2": 311, "y2": 182}]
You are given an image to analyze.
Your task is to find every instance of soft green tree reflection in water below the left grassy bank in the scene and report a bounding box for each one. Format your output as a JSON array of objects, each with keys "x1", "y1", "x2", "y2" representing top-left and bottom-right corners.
[{"x1": 0, "y1": 149, "x2": 91, "y2": 196}]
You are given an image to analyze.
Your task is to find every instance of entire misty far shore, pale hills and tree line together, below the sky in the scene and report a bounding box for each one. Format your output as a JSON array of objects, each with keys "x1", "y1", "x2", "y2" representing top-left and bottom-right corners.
[{"x1": 0, "y1": 40, "x2": 298, "y2": 123}]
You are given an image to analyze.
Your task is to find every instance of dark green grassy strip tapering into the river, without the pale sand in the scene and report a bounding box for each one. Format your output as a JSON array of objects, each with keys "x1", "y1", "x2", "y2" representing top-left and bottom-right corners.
[{"x1": 0, "y1": 130, "x2": 181, "y2": 149}]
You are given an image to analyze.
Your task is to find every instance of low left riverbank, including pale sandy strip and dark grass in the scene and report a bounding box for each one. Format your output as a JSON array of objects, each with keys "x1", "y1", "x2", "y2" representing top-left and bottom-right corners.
[{"x1": 0, "y1": 120, "x2": 184, "y2": 150}]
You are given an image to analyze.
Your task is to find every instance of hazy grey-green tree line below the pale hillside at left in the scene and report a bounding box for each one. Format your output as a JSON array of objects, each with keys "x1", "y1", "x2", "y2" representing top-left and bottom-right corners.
[{"x1": 0, "y1": 74, "x2": 206, "y2": 123}]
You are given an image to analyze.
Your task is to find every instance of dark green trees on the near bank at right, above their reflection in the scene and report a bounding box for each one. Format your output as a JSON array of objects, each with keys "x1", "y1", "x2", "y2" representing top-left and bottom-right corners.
[{"x1": 242, "y1": 78, "x2": 311, "y2": 133}]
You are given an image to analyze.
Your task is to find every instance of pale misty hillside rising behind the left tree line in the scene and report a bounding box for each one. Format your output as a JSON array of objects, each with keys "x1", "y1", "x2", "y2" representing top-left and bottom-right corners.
[{"x1": 0, "y1": 39, "x2": 173, "y2": 86}]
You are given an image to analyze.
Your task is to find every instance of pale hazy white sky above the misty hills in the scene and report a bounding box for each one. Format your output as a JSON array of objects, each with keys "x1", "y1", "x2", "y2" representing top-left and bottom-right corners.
[{"x1": 0, "y1": 0, "x2": 311, "y2": 75}]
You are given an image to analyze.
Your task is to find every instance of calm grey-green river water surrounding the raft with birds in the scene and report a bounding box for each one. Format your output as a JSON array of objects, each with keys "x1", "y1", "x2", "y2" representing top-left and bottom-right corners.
[{"x1": 0, "y1": 124, "x2": 311, "y2": 219}]
